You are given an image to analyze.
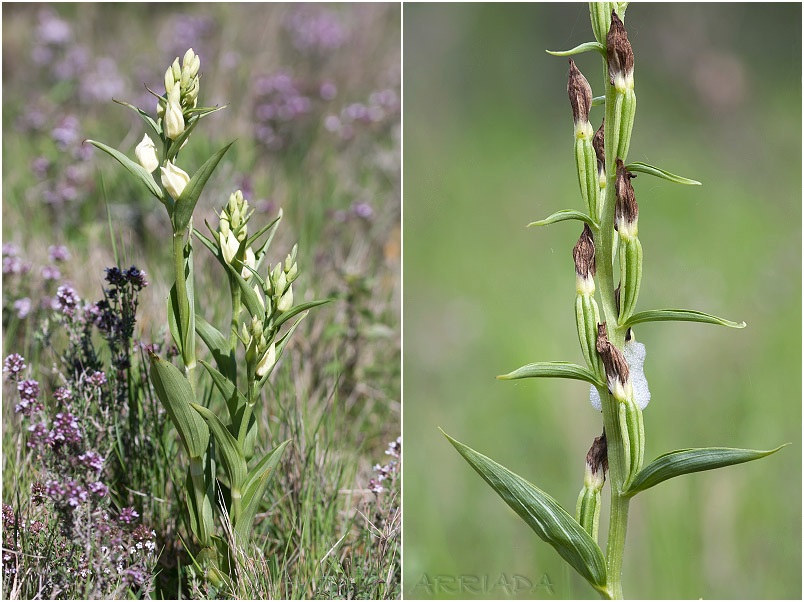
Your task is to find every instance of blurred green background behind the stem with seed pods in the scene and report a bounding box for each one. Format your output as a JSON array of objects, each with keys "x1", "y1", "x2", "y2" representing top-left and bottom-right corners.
[{"x1": 403, "y1": 3, "x2": 801, "y2": 599}]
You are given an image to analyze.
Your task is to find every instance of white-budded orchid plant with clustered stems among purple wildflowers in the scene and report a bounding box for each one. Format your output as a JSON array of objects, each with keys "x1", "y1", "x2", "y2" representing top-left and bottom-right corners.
[{"x1": 87, "y1": 49, "x2": 327, "y2": 587}]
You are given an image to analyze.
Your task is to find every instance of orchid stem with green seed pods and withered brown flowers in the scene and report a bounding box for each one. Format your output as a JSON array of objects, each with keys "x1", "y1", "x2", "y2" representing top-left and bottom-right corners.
[{"x1": 440, "y1": 2, "x2": 784, "y2": 599}]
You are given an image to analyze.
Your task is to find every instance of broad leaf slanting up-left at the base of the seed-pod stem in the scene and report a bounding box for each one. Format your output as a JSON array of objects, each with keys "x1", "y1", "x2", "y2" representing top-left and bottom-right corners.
[{"x1": 441, "y1": 431, "x2": 606, "y2": 592}]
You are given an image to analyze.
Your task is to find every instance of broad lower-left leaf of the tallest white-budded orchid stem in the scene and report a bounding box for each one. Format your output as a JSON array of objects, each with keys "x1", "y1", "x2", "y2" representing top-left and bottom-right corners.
[{"x1": 149, "y1": 353, "x2": 209, "y2": 458}]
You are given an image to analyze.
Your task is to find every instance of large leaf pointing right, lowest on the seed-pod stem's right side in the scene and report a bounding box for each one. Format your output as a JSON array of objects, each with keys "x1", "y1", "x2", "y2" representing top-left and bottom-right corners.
[{"x1": 625, "y1": 443, "x2": 790, "y2": 495}]
